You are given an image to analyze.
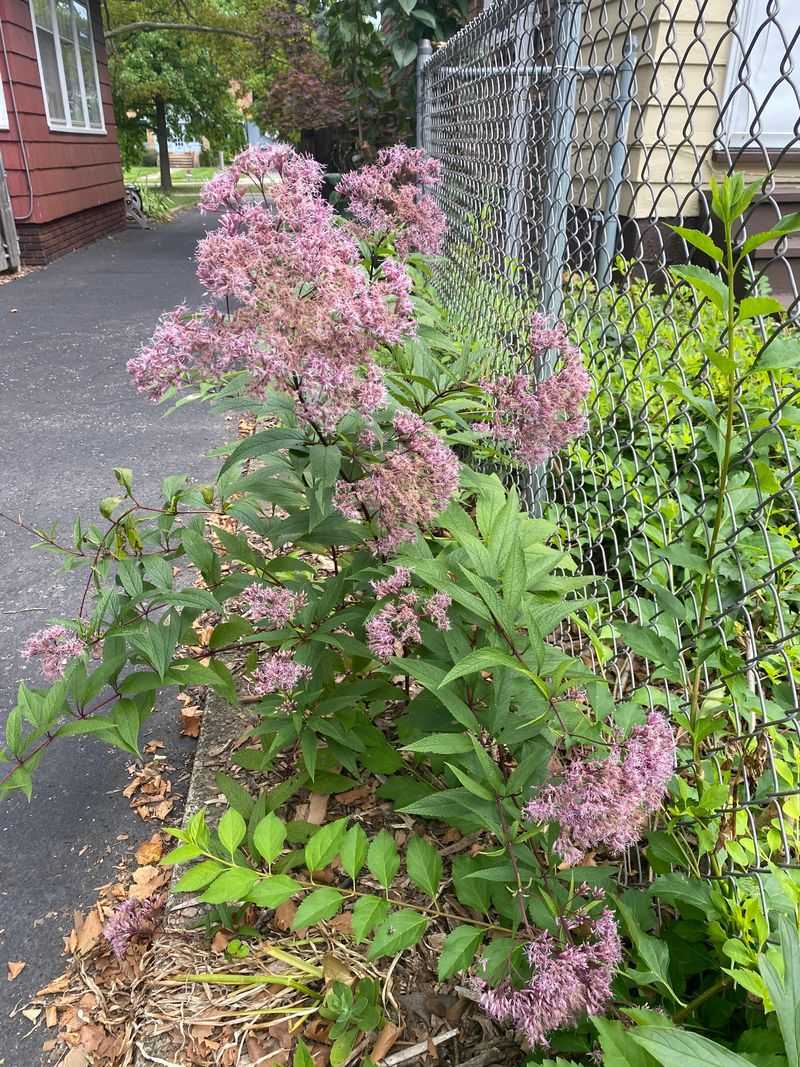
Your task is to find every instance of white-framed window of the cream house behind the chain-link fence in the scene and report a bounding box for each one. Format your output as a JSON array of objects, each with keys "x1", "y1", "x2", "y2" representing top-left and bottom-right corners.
[{"x1": 723, "y1": 0, "x2": 800, "y2": 149}]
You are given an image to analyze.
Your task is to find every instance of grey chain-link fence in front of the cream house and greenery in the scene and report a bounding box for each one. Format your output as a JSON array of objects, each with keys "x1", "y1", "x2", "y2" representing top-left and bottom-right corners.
[{"x1": 418, "y1": 0, "x2": 800, "y2": 870}]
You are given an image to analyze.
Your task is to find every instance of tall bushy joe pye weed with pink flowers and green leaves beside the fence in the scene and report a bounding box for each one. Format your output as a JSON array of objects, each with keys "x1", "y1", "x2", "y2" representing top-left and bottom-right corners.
[{"x1": 0, "y1": 154, "x2": 800, "y2": 1067}]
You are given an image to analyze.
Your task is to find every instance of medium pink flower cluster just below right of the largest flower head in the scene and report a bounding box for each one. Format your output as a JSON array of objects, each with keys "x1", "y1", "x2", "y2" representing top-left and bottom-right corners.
[{"x1": 334, "y1": 411, "x2": 459, "y2": 555}]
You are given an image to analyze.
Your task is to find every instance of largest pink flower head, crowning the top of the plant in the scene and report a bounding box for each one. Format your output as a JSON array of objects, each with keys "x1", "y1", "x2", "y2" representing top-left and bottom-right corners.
[{"x1": 128, "y1": 145, "x2": 414, "y2": 432}]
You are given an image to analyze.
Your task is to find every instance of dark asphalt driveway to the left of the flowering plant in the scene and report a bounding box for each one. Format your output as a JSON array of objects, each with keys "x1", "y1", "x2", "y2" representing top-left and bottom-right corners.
[{"x1": 0, "y1": 211, "x2": 221, "y2": 1067}]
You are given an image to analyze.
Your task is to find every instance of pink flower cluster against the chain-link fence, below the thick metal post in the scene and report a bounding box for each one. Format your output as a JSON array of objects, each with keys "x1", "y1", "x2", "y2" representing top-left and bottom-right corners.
[{"x1": 474, "y1": 315, "x2": 591, "y2": 464}]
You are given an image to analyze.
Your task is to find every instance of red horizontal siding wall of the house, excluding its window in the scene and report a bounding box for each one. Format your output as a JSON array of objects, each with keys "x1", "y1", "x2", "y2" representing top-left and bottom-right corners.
[{"x1": 0, "y1": 0, "x2": 125, "y2": 248}]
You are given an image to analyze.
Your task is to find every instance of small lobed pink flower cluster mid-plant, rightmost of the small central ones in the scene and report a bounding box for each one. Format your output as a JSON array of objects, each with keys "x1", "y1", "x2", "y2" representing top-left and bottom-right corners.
[{"x1": 364, "y1": 567, "x2": 451, "y2": 663}]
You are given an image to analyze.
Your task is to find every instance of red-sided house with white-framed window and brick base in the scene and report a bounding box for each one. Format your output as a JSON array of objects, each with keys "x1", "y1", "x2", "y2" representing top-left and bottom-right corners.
[{"x1": 0, "y1": 0, "x2": 125, "y2": 264}]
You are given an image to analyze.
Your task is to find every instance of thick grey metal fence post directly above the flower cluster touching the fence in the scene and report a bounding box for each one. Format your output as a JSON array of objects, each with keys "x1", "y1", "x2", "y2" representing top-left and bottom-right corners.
[{"x1": 540, "y1": 0, "x2": 583, "y2": 321}]
